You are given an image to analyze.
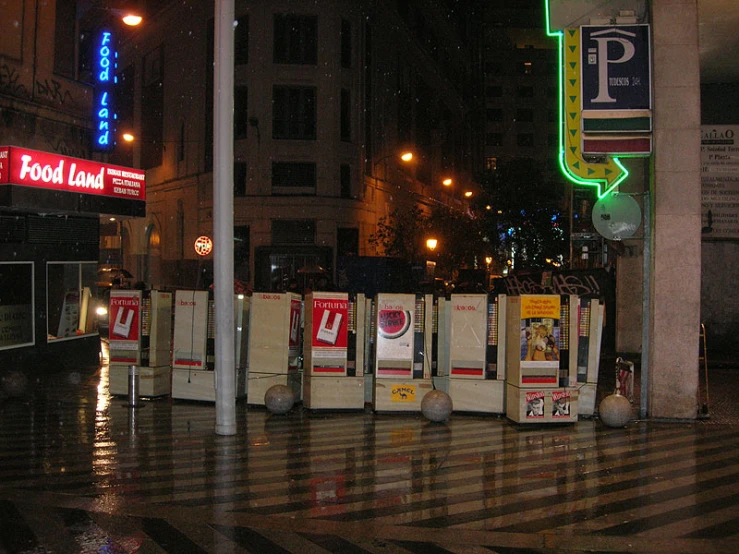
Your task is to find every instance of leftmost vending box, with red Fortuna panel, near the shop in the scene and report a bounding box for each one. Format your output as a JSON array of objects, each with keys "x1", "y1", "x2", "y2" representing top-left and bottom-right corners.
[{"x1": 108, "y1": 290, "x2": 172, "y2": 397}]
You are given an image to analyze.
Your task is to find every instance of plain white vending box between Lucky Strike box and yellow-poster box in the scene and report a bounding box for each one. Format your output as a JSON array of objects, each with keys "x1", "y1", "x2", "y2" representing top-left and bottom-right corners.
[{"x1": 446, "y1": 294, "x2": 506, "y2": 414}]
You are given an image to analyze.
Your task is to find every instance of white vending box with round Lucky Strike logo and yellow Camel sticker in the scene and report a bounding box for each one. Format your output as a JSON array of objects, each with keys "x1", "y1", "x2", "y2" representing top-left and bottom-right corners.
[{"x1": 372, "y1": 293, "x2": 433, "y2": 411}]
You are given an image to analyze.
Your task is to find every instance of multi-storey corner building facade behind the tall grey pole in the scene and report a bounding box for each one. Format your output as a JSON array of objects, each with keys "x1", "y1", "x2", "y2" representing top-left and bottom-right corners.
[{"x1": 108, "y1": 0, "x2": 476, "y2": 290}]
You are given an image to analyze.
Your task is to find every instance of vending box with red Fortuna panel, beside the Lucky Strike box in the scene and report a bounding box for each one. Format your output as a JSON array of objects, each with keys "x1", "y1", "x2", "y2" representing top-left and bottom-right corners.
[{"x1": 303, "y1": 292, "x2": 364, "y2": 409}]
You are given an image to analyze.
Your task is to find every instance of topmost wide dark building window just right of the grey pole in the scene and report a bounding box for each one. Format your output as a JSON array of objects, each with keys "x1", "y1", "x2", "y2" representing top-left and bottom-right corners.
[{"x1": 274, "y1": 14, "x2": 318, "y2": 65}]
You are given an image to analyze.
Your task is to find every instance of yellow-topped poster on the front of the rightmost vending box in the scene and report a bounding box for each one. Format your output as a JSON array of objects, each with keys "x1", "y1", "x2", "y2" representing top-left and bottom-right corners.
[{"x1": 521, "y1": 295, "x2": 560, "y2": 368}]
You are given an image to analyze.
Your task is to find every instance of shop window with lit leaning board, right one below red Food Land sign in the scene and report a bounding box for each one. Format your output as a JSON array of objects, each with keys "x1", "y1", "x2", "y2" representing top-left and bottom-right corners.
[{"x1": 46, "y1": 262, "x2": 97, "y2": 341}]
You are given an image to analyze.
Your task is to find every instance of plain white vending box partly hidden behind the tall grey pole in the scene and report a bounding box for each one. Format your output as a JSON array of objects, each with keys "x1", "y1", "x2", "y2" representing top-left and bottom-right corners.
[{"x1": 172, "y1": 290, "x2": 249, "y2": 402}]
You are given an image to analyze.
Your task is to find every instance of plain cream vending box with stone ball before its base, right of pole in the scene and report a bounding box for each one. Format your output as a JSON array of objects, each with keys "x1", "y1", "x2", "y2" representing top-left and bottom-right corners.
[{"x1": 247, "y1": 292, "x2": 303, "y2": 406}]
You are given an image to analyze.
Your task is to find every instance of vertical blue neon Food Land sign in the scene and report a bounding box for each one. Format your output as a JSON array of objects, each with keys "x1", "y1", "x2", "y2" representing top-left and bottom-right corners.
[{"x1": 92, "y1": 30, "x2": 118, "y2": 152}]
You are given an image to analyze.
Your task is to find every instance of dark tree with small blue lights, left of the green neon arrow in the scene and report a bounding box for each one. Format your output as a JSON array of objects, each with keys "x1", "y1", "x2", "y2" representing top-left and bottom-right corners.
[{"x1": 477, "y1": 158, "x2": 569, "y2": 269}]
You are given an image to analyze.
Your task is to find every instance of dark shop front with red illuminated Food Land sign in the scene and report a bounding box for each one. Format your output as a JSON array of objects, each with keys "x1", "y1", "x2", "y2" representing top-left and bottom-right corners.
[{"x1": 0, "y1": 146, "x2": 146, "y2": 370}]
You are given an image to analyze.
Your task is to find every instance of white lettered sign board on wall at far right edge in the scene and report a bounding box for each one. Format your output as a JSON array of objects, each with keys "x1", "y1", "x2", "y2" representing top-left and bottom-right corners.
[{"x1": 701, "y1": 125, "x2": 739, "y2": 240}]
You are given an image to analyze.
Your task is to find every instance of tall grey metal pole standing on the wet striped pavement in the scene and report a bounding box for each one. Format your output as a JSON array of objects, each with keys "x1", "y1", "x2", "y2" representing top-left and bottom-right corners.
[{"x1": 213, "y1": 0, "x2": 236, "y2": 435}]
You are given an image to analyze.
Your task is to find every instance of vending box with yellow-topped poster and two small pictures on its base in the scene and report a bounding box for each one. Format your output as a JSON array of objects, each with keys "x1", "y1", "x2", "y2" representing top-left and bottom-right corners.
[{"x1": 506, "y1": 294, "x2": 579, "y2": 423}]
